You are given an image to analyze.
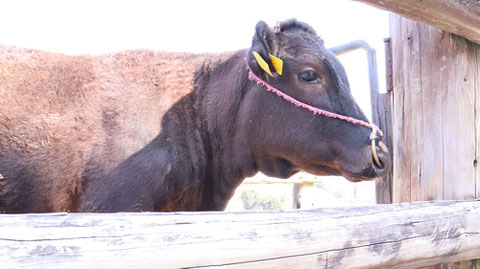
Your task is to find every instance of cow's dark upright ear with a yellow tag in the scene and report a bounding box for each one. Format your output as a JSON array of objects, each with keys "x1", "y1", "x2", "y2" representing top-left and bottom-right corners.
[{"x1": 248, "y1": 21, "x2": 274, "y2": 76}]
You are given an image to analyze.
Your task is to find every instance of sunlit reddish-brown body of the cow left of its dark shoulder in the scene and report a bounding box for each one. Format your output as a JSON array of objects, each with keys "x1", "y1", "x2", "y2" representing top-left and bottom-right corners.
[{"x1": 0, "y1": 47, "x2": 208, "y2": 212}]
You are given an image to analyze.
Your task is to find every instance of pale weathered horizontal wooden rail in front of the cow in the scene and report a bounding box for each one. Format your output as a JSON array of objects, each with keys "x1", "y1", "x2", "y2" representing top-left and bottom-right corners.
[{"x1": 0, "y1": 201, "x2": 480, "y2": 269}]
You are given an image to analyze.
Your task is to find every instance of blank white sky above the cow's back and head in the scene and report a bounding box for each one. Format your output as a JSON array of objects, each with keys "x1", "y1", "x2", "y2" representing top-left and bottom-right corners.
[{"x1": 0, "y1": 0, "x2": 388, "y2": 54}]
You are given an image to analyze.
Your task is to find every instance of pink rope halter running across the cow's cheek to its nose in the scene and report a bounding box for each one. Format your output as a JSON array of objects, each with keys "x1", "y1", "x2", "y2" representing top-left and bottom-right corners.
[{"x1": 248, "y1": 67, "x2": 383, "y2": 167}]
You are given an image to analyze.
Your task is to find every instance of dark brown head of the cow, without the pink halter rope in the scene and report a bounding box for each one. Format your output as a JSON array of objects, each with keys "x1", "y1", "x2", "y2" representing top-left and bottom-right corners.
[{"x1": 245, "y1": 20, "x2": 391, "y2": 181}]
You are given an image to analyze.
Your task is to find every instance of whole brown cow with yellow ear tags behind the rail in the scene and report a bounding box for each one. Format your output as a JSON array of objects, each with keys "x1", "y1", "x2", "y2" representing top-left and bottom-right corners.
[{"x1": 0, "y1": 20, "x2": 390, "y2": 213}]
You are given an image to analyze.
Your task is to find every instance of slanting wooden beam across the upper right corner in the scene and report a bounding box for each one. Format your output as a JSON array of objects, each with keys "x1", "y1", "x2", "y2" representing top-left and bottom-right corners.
[{"x1": 356, "y1": 0, "x2": 480, "y2": 44}]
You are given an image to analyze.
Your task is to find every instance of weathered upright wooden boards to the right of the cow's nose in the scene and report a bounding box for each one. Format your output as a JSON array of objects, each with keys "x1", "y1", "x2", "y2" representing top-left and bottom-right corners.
[{"x1": 390, "y1": 15, "x2": 480, "y2": 268}]
